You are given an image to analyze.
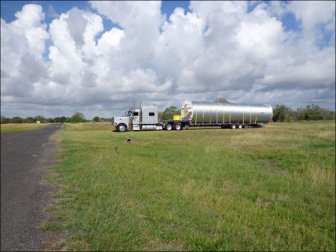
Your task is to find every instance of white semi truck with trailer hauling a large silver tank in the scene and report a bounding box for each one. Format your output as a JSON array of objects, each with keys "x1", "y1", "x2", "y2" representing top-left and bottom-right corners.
[{"x1": 112, "y1": 101, "x2": 273, "y2": 132}]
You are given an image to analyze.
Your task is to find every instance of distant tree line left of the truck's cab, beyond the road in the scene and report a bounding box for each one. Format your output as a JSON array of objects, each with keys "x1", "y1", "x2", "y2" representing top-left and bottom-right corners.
[{"x1": 1, "y1": 112, "x2": 111, "y2": 124}]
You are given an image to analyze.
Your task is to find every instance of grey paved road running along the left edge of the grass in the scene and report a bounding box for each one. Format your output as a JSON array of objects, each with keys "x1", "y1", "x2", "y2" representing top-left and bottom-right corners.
[{"x1": 1, "y1": 124, "x2": 63, "y2": 251}]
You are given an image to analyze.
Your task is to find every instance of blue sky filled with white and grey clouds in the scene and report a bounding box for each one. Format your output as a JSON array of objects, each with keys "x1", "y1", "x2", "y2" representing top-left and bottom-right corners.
[{"x1": 1, "y1": 1, "x2": 335, "y2": 119}]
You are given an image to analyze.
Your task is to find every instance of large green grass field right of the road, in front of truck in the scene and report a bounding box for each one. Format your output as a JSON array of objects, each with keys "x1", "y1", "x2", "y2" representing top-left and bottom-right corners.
[{"x1": 42, "y1": 121, "x2": 335, "y2": 251}]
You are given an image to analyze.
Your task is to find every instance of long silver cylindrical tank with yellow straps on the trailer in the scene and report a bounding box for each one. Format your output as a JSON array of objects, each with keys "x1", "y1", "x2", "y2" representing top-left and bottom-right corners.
[{"x1": 181, "y1": 101, "x2": 273, "y2": 124}]
